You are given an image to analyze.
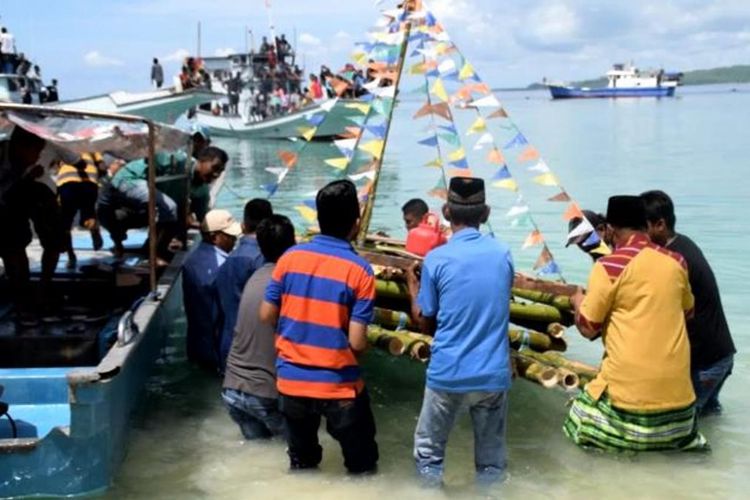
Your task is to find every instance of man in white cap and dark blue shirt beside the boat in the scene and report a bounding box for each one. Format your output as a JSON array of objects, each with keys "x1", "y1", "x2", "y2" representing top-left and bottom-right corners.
[{"x1": 182, "y1": 209, "x2": 242, "y2": 371}]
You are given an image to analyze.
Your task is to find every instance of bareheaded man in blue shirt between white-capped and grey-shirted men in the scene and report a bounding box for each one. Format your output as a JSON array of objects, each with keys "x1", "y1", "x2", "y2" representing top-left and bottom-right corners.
[{"x1": 216, "y1": 198, "x2": 273, "y2": 374}]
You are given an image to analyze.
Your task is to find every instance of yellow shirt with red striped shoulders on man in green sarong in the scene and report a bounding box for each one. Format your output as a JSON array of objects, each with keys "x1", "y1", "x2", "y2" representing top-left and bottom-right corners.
[{"x1": 580, "y1": 234, "x2": 695, "y2": 411}]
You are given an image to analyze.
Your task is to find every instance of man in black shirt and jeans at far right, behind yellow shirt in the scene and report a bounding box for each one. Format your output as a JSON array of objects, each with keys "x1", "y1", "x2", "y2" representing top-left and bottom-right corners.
[{"x1": 641, "y1": 191, "x2": 737, "y2": 416}]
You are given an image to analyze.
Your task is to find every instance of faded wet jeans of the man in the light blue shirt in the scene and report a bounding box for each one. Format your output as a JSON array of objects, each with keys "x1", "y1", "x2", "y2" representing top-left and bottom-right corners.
[{"x1": 414, "y1": 387, "x2": 508, "y2": 485}]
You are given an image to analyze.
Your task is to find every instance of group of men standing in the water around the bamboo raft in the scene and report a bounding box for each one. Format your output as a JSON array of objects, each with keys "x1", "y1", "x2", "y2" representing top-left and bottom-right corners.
[{"x1": 178, "y1": 174, "x2": 735, "y2": 485}]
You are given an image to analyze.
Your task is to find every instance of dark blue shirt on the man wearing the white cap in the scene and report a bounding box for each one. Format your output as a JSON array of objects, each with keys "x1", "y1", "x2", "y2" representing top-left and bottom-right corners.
[{"x1": 182, "y1": 241, "x2": 227, "y2": 367}]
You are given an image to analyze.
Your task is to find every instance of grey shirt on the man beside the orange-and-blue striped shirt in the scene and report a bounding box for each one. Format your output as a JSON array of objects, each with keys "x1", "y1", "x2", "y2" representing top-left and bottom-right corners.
[{"x1": 224, "y1": 257, "x2": 278, "y2": 398}]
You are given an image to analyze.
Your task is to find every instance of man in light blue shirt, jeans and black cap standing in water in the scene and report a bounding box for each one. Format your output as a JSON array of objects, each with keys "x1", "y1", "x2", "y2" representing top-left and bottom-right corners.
[{"x1": 407, "y1": 177, "x2": 513, "y2": 486}]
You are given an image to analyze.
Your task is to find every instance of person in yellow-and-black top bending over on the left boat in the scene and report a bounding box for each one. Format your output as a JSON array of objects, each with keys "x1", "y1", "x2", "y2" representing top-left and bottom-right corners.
[{"x1": 57, "y1": 153, "x2": 104, "y2": 269}]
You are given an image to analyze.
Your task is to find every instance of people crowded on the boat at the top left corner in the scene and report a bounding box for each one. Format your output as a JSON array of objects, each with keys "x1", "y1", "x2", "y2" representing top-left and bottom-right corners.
[{"x1": 0, "y1": 26, "x2": 60, "y2": 104}]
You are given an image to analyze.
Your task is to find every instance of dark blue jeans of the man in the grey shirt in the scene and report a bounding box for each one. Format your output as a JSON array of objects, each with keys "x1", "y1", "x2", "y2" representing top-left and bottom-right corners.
[{"x1": 221, "y1": 389, "x2": 286, "y2": 440}]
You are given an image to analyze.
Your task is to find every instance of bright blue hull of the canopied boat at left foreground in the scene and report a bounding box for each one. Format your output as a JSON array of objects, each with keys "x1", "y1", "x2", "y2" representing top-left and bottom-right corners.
[{"x1": 0, "y1": 254, "x2": 189, "y2": 497}]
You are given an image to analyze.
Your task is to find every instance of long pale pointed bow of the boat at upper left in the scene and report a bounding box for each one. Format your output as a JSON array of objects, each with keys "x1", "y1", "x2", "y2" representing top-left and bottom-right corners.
[{"x1": 54, "y1": 89, "x2": 218, "y2": 124}]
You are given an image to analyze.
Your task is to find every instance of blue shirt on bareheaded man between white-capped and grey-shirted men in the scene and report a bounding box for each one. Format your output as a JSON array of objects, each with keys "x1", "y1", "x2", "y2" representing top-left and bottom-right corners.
[{"x1": 216, "y1": 235, "x2": 265, "y2": 370}]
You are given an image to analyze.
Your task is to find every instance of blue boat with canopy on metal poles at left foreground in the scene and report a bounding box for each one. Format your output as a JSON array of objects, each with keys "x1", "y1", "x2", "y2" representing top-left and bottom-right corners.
[{"x1": 0, "y1": 104, "x2": 206, "y2": 497}]
